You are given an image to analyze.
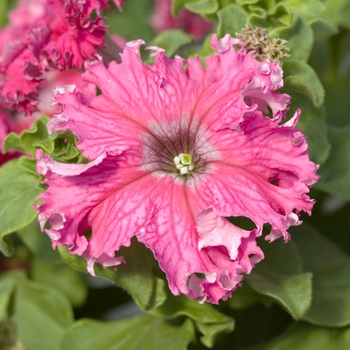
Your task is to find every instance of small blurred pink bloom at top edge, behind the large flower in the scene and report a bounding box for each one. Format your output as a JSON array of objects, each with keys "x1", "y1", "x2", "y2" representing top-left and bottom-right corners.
[{"x1": 151, "y1": 0, "x2": 213, "y2": 39}]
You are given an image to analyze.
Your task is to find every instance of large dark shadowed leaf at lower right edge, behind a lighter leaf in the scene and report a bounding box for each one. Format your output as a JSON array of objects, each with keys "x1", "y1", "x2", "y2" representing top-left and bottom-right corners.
[{"x1": 291, "y1": 224, "x2": 350, "y2": 327}]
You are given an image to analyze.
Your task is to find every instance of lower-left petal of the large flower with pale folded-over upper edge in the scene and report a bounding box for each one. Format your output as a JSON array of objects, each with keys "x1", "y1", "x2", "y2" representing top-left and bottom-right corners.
[{"x1": 36, "y1": 151, "x2": 152, "y2": 272}]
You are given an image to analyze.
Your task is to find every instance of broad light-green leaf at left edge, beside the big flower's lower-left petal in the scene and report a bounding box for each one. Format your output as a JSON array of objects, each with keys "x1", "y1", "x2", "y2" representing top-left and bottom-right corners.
[{"x1": 0, "y1": 158, "x2": 43, "y2": 256}]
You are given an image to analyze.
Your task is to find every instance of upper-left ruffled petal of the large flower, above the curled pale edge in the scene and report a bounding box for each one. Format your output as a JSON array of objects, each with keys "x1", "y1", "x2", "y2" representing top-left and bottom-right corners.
[{"x1": 48, "y1": 85, "x2": 144, "y2": 159}]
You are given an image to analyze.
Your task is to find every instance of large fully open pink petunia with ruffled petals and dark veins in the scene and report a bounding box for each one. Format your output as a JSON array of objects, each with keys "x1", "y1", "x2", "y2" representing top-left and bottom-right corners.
[{"x1": 37, "y1": 35, "x2": 318, "y2": 303}]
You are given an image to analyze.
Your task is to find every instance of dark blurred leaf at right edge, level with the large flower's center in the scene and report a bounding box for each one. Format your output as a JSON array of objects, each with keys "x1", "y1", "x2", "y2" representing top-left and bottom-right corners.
[{"x1": 315, "y1": 126, "x2": 350, "y2": 200}]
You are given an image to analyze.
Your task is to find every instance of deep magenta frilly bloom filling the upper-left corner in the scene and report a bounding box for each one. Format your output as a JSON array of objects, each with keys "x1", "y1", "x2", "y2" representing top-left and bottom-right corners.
[{"x1": 0, "y1": 0, "x2": 122, "y2": 114}]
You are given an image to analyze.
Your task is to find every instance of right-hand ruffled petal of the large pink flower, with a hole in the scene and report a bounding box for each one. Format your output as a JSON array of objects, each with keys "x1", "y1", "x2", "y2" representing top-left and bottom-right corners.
[{"x1": 202, "y1": 114, "x2": 318, "y2": 240}]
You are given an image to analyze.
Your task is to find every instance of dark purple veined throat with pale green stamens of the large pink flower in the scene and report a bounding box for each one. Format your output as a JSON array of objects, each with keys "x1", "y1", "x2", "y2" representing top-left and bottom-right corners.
[{"x1": 141, "y1": 116, "x2": 220, "y2": 188}]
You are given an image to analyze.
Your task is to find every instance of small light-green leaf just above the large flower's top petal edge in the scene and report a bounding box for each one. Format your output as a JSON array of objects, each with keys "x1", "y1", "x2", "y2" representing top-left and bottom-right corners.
[{"x1": 152, "y1": 29, "x2": 193, "y2": 57}]
